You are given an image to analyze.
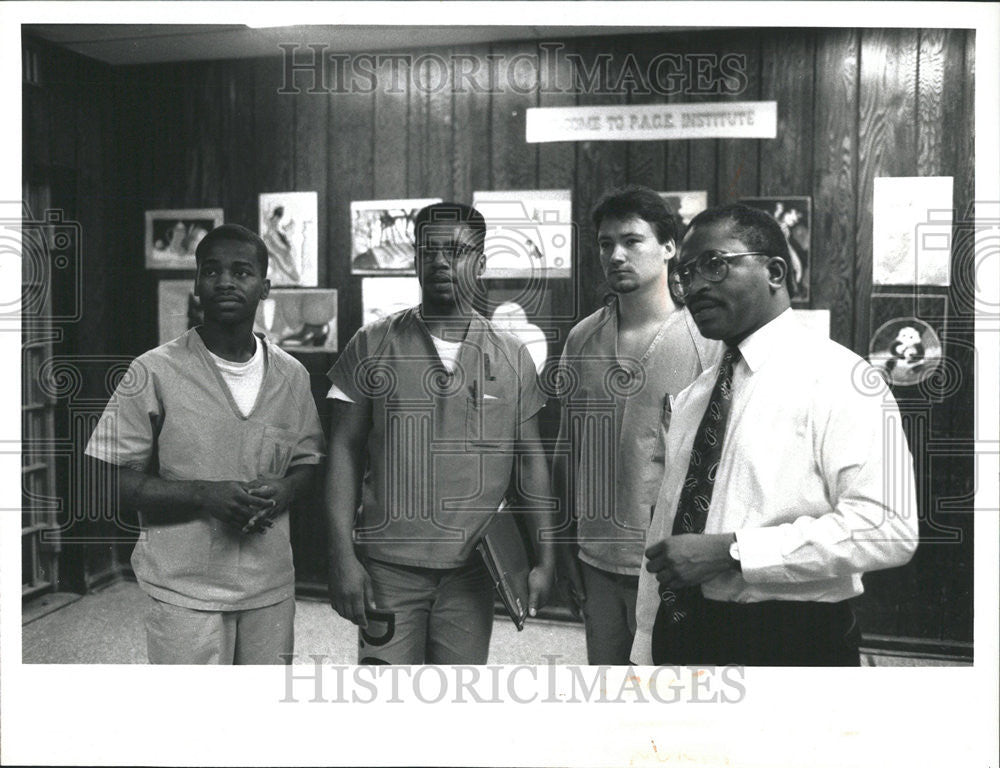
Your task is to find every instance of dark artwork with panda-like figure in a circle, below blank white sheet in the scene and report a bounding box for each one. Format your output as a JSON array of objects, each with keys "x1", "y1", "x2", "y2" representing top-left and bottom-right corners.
[{"x1": 868, "y1": 293, "x2": 948, "y2": 387}]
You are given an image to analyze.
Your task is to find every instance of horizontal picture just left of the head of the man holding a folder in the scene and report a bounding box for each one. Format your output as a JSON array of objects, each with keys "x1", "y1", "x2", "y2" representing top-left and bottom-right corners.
[{"x1": 351, "y1": 197, "x2": 441, "y2": 275}]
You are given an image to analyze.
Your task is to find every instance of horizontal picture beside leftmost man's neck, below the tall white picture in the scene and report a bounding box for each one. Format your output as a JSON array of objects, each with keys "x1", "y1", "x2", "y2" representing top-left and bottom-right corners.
[{"x1": 254, "y1": 288, "x2": 337, "y2": 352}]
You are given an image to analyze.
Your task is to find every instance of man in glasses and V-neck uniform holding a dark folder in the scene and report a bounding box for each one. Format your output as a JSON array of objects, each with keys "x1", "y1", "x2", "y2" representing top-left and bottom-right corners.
[{"x1": 326, "y1": 203, "x2": 554, "y2": 664}]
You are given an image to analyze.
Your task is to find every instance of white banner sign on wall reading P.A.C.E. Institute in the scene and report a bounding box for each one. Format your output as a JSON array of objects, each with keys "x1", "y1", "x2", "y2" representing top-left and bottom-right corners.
[{"x1": 525, "y1": 101, "x2": 778, "y2": 144}]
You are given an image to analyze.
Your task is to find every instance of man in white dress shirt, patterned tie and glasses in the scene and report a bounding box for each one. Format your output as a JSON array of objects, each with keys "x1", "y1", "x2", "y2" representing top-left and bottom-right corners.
[{"x1": 632, "y1": 205, "x2": 918, "y2": 666}]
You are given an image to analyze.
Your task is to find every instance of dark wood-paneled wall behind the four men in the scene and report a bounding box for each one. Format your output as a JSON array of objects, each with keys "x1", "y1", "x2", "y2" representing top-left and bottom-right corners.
[{"x1": 25, "y1": 29, "x2": 974, "y2": 640}]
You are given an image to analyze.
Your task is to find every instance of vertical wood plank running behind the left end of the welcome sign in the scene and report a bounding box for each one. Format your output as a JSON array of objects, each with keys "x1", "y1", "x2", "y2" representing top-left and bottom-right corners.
[{"x1": 490, "y1": 43, "x2": 538, "y2": 190}]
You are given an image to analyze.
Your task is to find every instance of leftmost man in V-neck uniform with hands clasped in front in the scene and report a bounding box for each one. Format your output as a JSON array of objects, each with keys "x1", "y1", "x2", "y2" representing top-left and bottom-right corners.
[{"x1": 86, "y1": 224, "x2": 323, "y2": 664}]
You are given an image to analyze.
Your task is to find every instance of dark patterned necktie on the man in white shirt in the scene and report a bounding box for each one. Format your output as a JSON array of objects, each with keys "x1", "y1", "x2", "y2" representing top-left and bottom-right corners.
[{"x1": 653, "y1": 347, "x2": 740, "y2": 636}]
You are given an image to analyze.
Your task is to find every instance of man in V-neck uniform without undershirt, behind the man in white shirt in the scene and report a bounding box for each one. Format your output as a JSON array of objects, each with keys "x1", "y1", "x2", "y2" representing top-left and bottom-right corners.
[{"x1": 555, "y1": 186, "x2": 721, "y2": 664}]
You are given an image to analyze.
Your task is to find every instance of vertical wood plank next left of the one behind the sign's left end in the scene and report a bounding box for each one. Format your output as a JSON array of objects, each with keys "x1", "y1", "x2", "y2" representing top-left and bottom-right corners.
[{"x1": 452, "y1": 45, "x2": 493, "y2": 204}]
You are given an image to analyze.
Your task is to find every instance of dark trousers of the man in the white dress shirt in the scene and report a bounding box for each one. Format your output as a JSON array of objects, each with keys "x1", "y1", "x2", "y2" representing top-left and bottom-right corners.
[{"x1": 653, "y1": 590, "x2": 861, "y2": 667}]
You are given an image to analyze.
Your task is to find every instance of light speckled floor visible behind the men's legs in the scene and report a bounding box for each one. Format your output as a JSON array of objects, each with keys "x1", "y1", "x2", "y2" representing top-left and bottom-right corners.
[{"x1": 21, "y1": 582, "x2": 968, "y2": 666}]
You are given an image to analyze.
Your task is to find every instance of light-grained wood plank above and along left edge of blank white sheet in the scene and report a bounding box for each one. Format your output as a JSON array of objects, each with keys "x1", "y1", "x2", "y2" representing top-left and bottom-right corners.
[{"x1": 853, "y1": 29, "x2": 917, "y2": 354}]
